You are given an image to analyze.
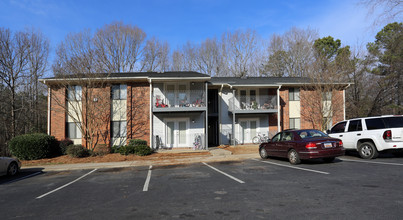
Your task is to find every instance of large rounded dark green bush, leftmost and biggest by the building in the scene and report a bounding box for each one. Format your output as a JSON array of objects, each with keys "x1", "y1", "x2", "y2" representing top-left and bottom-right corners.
[{"x1": 9, "y1": 134, "x2": 60, "y2": 160}]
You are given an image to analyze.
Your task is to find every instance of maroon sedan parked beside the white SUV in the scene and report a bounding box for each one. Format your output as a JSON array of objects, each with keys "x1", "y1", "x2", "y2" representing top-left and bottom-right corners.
[{"x1": 259, "y1": 129, "x2": 345, "y2": 164}]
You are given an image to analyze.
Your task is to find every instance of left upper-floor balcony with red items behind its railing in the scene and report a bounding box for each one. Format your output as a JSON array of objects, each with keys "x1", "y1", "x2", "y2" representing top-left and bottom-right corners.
[{"x1": 153, "y1": 90, "x2": 207, "y2": 112}]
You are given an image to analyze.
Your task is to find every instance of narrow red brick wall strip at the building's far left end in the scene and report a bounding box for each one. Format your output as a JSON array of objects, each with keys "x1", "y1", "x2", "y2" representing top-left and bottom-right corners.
[{"x1": 50, "y1": 86, "x2": 66, "y2": 140}]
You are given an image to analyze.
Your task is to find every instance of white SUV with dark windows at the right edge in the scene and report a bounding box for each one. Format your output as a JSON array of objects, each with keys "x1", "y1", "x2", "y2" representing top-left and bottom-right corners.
[{"x1": 327, "y1": 115, "x2": 403, "y2": 159}]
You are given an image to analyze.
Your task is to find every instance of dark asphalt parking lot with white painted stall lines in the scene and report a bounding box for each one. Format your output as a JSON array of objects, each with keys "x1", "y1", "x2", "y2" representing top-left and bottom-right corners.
[{"x1": 0, "y1": 155, "x2": 403, "y2": 219}]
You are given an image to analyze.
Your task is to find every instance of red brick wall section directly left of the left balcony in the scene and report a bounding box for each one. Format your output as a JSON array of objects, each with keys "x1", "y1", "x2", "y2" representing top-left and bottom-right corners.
[{"x1": 127, "y1": 83, "x2": 151, "y2": 145}]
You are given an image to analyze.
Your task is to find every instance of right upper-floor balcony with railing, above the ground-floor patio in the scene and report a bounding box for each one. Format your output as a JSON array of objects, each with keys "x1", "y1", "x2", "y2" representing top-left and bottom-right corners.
[{"x1": 228, "y1": 95, "x2": 277, "y2": 113}]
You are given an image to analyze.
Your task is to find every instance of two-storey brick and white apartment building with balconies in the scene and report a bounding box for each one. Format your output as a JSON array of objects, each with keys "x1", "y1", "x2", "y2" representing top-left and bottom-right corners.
[{"x1": 40, "y1": 72, "x2": 348, "y2": 149}]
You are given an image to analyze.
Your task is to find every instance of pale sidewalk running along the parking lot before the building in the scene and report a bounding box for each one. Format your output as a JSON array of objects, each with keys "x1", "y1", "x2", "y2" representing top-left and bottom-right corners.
[{"x1": 21, "y1": 146, "x2": 259, "y2": 172}]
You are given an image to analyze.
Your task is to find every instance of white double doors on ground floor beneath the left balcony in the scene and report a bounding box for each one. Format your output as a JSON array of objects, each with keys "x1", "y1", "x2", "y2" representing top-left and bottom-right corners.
[{"x1": 165, "y1": 119, "x2": 189, "y2": 148}]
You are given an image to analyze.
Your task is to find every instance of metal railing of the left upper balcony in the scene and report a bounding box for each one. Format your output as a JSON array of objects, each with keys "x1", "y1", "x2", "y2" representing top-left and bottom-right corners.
[{"x1": 153, "y1": 90, "x2": 207, "y2": 108}]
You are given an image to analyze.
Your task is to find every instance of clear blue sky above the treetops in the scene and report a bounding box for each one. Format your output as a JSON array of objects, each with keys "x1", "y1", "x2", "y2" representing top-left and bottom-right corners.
[{"x1": 0, "y1": 0, "x2": 398, "y2": 66}]
